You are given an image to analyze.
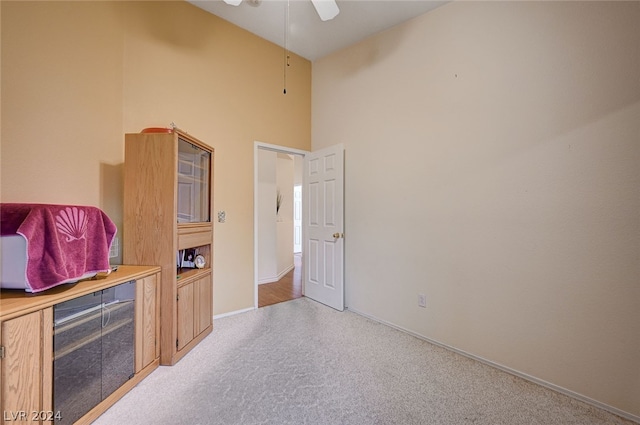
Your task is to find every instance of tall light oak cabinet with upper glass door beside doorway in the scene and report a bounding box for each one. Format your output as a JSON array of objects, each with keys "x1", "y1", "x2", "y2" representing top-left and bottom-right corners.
[{"x1": 123, "y1": 129, "x2": 214, "y2": 365}]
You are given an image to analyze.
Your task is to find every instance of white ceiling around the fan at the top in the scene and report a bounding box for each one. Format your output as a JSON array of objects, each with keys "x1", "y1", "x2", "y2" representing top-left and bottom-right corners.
[{"x1": 187, "y1": 0, "x2": 446, "y2": 61}]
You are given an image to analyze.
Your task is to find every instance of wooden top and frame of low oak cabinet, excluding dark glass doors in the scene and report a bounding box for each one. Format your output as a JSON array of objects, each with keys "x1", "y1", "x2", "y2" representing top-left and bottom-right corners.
[{"x1": 0, "y1": 266, "x2": 161, "y2": 424}]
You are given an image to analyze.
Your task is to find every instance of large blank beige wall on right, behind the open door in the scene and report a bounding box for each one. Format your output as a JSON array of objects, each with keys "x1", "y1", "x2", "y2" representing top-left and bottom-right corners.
[{"x1": 312, "y1": 2, "x2": 640, "y2": 418}]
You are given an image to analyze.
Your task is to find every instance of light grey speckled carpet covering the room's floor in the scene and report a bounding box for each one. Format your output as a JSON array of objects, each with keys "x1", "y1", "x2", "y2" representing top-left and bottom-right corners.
[{"x1": 94, "y1": 298, "x2": 633, "y2": 425}]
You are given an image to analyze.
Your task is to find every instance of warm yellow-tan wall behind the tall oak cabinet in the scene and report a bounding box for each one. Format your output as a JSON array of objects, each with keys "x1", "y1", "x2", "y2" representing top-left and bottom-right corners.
[{"x1": 0, "y1": 1, "x2": 311, "y2": 314}]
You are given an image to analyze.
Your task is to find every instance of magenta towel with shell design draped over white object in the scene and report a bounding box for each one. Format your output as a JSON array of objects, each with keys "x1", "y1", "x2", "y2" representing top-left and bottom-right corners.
[{"x1": 0, "y1": 204, "x2": 117, "y2": 292}]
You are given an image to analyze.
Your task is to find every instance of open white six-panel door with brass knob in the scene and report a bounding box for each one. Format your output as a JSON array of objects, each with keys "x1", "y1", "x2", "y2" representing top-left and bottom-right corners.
[{"x1": 303, "y1": 144, "x2": 344, "y2": 311}]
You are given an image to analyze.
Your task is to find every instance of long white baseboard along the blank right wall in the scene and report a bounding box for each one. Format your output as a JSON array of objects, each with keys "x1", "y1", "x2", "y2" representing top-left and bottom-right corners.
[{"x1": 348, "y1": 308, "x2": 640, "y2": 424}]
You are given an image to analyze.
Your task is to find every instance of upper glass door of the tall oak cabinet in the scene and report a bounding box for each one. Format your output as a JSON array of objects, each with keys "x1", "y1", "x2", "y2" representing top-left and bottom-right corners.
[{"x1": 178, "y1": 138, "x2": 211, "y2": 223}]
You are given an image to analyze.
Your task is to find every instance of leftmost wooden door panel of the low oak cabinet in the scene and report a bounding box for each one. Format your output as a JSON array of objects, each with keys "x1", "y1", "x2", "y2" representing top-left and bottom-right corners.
[{"x1": 0, "y1": 311, "x2": 42, "y2": 423}]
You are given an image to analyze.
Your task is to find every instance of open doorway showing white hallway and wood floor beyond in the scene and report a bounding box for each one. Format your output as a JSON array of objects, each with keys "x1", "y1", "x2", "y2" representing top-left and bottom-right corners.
[{"x1": 254, "y1": 142, "x2": 307, "y2": 308}]
